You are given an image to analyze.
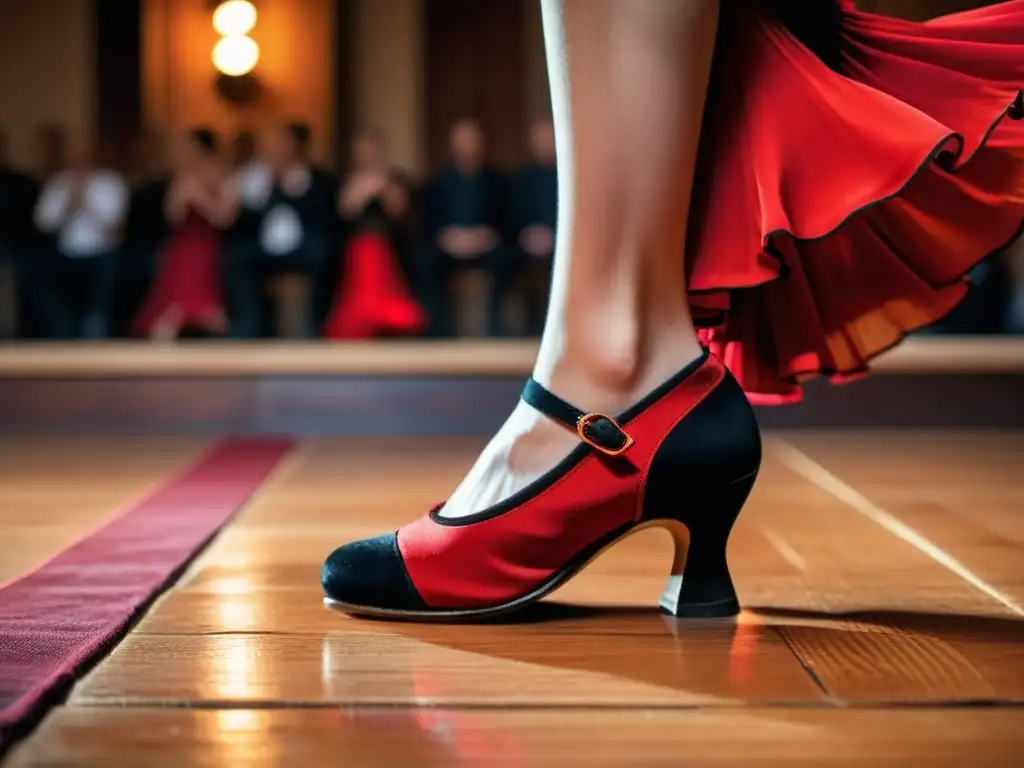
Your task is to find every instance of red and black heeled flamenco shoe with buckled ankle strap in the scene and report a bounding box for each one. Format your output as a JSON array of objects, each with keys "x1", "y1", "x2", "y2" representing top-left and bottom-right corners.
[{"x1": 322, "y1": 351, "x2": 761, "y2": 621}]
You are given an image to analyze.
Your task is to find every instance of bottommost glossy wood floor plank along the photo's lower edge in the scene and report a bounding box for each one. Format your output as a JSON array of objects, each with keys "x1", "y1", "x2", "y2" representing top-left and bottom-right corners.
[{"x1": 10, "y1": 708, "x2": 1024, "y2": 768}]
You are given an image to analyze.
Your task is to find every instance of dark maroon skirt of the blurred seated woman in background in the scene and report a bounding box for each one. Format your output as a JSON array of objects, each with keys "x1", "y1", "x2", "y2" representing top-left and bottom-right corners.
[{"x1": 134, "y1": 209, "x2": 224, "y2": 336}]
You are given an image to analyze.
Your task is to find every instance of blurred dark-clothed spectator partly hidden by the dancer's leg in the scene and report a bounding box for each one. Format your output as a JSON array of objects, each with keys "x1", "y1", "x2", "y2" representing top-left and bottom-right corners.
[{"x1": 512, "y1": 120, "x2": 558, "y2": 336}]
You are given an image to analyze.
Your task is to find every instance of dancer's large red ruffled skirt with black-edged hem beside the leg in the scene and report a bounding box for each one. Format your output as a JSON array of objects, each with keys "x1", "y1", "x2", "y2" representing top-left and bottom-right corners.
[{"x1": 687, "y1": 0, "x2": 1024, "y2": 403}]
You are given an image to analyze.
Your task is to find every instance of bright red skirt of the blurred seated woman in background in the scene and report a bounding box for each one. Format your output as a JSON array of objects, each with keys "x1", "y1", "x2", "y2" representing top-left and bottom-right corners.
[{"x1": 324, "y1": 232, "x2": 426, "y2": 339}]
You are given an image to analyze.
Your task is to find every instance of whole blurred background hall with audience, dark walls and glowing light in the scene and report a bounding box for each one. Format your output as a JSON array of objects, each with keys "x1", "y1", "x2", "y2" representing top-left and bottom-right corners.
[{"x1": 0, "y1": 0, "x2": 1024, "y2": 341}]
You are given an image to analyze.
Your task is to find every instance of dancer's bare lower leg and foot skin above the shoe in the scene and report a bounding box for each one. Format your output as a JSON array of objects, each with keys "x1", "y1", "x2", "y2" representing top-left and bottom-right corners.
[{"x1": 441, "y1": 0, "x2": 718, "y2": 517}]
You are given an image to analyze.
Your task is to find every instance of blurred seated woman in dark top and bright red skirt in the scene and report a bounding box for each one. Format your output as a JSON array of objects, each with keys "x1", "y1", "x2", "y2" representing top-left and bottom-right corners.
[{"x1": 324, "y1": 133, "x2": 426, "y2": 339}]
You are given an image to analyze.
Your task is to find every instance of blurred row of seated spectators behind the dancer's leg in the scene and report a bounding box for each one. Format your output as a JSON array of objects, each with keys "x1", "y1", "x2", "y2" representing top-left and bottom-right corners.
[{"x1": 0, "y1": 115, "x2": 1024, "y2": 340}]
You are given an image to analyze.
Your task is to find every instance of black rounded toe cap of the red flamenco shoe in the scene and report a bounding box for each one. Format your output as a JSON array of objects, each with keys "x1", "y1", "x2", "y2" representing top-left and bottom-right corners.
[{"x1": 321, "y1": 534, "x2": 427, "y2": 611}]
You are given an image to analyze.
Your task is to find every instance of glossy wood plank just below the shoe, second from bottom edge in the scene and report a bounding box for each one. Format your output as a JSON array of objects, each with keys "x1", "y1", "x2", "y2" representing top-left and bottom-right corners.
[{"x1": 71, "y1": 618, "x2": 822, "y2": 707}]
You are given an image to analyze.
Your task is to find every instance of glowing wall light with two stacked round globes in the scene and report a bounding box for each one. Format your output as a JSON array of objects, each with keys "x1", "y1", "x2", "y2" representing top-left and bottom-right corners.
[{"x1": 213, "y1": 0, "x2": 260, "y2": 102}]
